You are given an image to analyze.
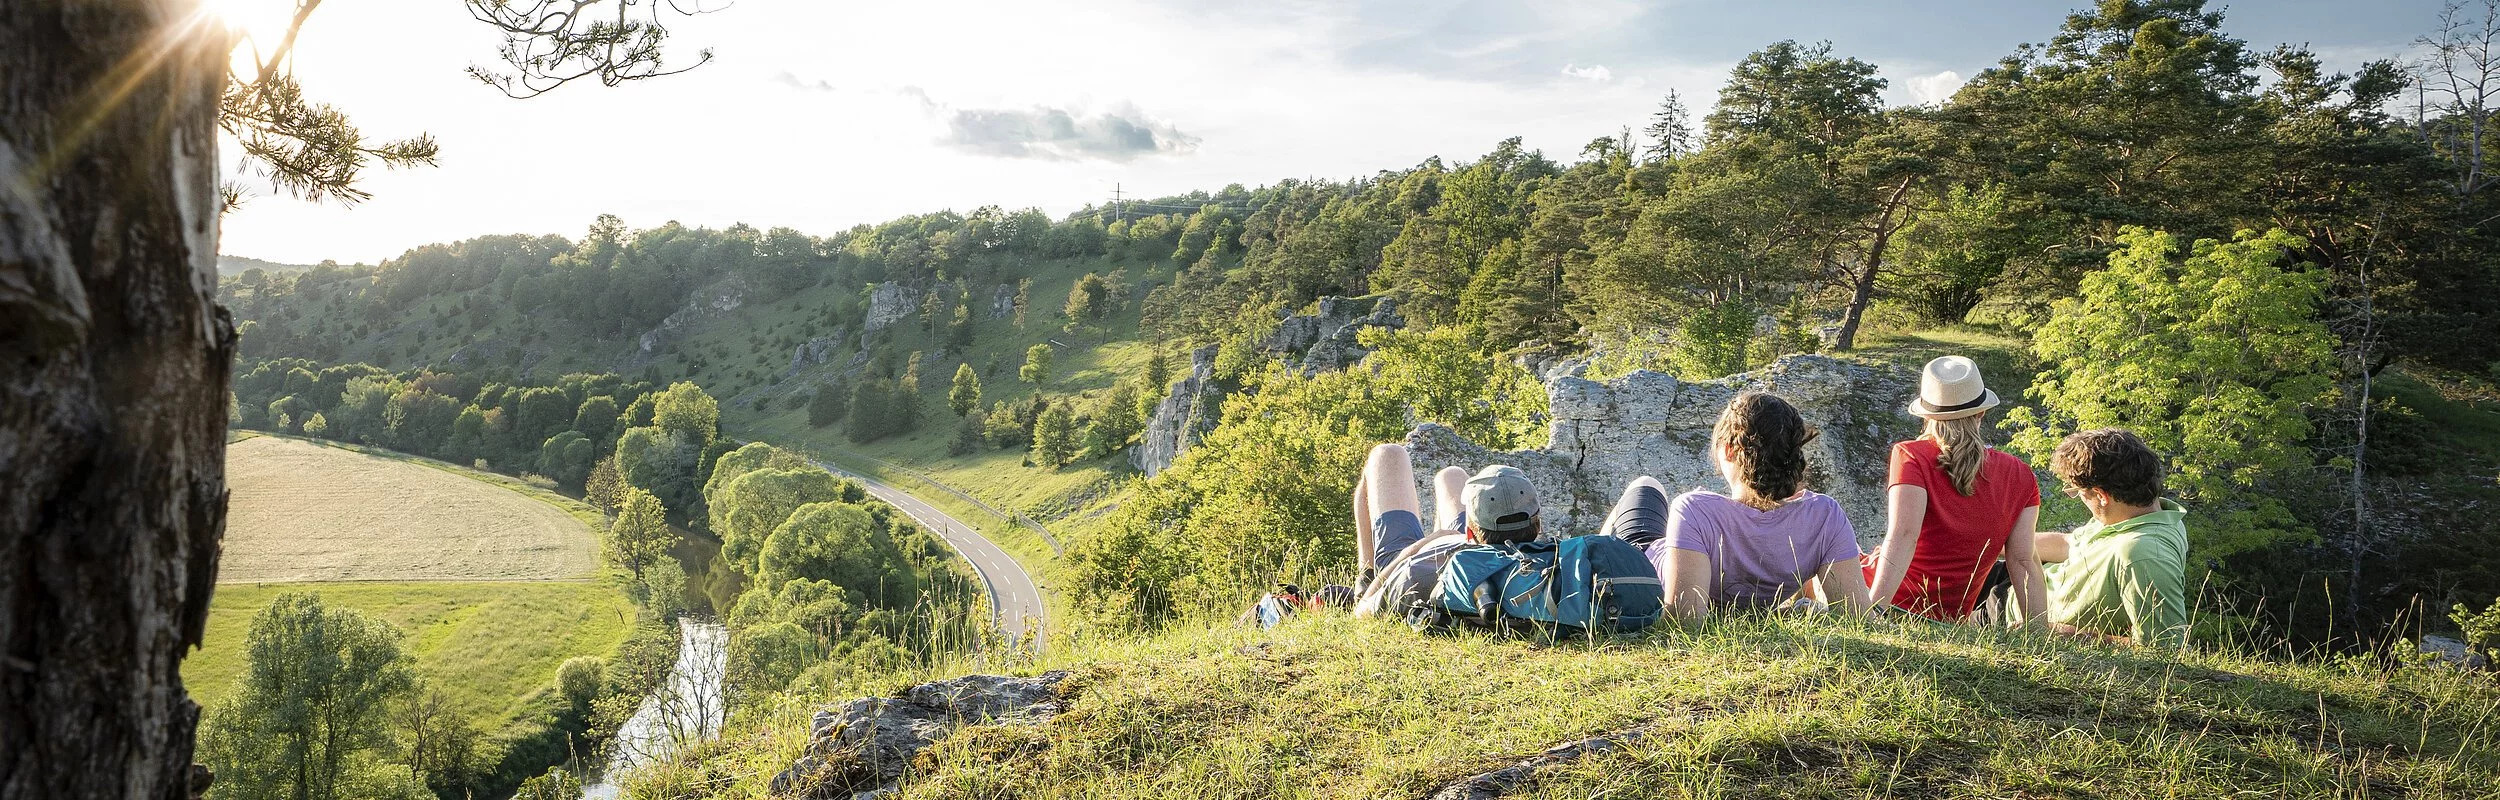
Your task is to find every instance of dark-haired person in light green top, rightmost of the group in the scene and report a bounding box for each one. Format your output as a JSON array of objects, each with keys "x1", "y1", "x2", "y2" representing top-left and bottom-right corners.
[{"x1": 2038, "y1": 428, "x2": 2188, "y2": 648}]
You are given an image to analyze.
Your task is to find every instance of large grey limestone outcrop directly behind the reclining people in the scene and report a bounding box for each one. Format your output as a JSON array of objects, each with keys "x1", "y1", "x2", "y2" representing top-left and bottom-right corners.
[{"x1": 1408, "y1": 355, "x2": 1918, "y2": 543}]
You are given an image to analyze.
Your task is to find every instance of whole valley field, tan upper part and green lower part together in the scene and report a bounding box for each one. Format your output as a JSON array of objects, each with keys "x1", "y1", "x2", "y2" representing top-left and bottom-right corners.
[{"x1": 183, "y1": 435, "x2": 635, "y2": 730}]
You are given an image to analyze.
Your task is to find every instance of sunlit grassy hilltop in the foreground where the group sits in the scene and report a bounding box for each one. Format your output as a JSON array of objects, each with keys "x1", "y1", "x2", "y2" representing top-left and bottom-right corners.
[{"x1": 620, "y1": 615, "x2": 2500, "y2": 798}]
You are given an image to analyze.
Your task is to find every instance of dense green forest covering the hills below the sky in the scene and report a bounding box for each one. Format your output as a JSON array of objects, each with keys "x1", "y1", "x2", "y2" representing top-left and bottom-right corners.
[{"x1": 220, "y1": 0, "x2": 2500, "y2": 643}]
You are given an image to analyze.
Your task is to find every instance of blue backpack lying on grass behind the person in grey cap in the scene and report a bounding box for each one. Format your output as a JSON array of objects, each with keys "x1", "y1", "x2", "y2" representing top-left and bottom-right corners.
[{"x1": 1435, "y1": 535, "x2": 1668, "y2": 633}]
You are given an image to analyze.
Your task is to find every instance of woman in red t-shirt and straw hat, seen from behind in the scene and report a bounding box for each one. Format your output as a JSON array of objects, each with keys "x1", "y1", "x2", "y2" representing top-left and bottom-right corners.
[{"x1": 1868, "y1": 355, "x2": 2048, "y2": 623}]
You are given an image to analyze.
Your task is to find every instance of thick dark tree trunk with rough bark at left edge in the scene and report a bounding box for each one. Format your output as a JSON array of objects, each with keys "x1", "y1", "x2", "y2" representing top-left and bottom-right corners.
[{"x1": 0, "y1": 0, "x2": 235, "y2": 800}]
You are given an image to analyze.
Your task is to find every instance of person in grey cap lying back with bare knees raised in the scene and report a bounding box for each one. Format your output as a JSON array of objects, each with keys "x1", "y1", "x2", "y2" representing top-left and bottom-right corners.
[{"x1": 1355, "y1": 445, "x2": 1540, "y2": 618}]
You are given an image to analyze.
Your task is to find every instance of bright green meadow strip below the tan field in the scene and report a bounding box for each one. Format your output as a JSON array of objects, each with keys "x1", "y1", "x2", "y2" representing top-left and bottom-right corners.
[{"x1": 183, "y1": 580, "x2": 633, "y2": 730}]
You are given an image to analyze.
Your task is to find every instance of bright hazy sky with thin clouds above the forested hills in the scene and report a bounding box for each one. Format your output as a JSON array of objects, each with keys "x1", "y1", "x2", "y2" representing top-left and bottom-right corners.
[{"x1": 213, "y1": 0, "x2": 2438, "y2": 263}]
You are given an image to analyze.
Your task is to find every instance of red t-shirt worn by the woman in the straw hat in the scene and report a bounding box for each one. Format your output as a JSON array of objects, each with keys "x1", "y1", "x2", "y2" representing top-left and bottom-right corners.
[{"x1": 1870, "y1": 438, "x2": 2040, "y2": 620}]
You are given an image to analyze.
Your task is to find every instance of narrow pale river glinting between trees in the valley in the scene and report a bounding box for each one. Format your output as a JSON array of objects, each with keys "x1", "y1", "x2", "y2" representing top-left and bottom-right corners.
[{"x1": 583, "y1": 618, "x2": 730, "y2": 800}]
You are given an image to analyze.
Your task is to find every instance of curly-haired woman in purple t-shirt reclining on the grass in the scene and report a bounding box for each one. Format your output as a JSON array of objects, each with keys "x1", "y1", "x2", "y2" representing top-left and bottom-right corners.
[{"x1": 1605, "y1": 393, "x2": 1873, "y2": 620}]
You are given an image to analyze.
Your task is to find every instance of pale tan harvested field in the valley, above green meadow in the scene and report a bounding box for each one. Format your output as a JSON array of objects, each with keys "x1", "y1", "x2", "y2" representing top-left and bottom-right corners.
[{"x1": 218, "y1": 438, "x2": 598, "y2": 583}]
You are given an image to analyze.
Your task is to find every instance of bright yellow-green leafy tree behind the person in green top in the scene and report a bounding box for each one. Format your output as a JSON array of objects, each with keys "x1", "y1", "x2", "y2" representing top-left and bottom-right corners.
[{"x1": 2008, "y1": 228, "x2": 2335, "y2": 563}]
